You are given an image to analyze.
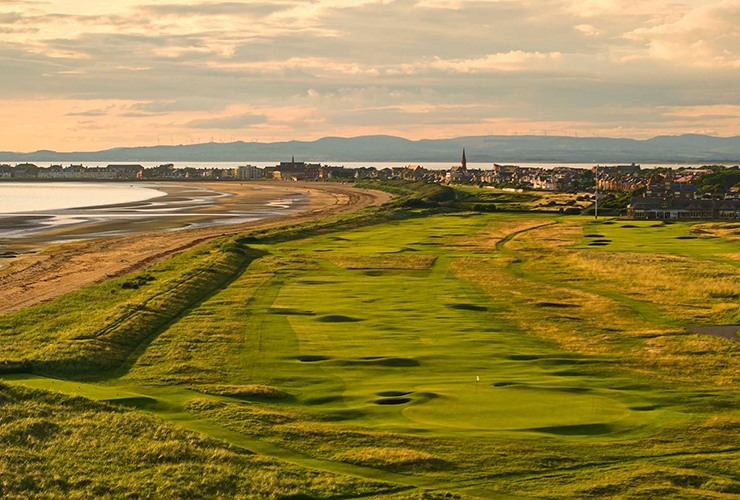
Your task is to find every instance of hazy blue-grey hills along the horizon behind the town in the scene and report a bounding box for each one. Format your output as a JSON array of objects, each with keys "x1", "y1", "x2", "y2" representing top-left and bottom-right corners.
[{"x1": 0, "y1": 134, "x2": 740, "y2": 163}]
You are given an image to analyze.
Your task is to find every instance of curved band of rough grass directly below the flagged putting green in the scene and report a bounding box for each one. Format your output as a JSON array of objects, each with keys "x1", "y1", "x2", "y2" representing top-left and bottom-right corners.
[{"x1": 190, "y1": 392, "x2": 740, "y2": 499}]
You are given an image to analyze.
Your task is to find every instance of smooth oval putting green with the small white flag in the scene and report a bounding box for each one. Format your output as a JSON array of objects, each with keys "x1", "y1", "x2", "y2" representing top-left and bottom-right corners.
[{"x1": 403, "y1": 383, "x2": 631, "y2": 434}]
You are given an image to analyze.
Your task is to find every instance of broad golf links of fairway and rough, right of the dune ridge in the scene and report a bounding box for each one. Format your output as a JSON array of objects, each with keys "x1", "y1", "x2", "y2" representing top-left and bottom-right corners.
[{"x1": 10, "y1": 205, "x2": 740, "y2": 499}]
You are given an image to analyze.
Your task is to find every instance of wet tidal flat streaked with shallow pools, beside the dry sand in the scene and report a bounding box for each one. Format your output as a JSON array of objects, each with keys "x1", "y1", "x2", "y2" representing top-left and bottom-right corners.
[{"x1": 0, "y1": 181, "x2": 311, "y2": 254}]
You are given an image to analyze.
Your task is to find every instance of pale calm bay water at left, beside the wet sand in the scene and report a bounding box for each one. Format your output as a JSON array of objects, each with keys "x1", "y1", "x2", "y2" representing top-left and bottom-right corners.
[{"x1": 0, "y1": 182, "x2": 166, "y2": 214}]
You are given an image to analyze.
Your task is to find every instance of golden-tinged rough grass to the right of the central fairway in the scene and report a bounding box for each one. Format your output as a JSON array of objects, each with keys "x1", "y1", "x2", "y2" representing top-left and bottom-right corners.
[{"x1": 482, "y1": 222, "x2": 740, "y2": 386}]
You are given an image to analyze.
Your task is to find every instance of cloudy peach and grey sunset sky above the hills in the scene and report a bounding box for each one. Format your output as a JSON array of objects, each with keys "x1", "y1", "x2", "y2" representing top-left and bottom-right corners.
[{"x1": 0, "y1": 0, "x2": 740, "y2": 151}]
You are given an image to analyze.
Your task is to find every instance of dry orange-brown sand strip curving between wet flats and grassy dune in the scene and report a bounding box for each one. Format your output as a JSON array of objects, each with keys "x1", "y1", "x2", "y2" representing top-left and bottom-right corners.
[{"x1": 0, "y1": 183, "x2": 392, "y2": 314}]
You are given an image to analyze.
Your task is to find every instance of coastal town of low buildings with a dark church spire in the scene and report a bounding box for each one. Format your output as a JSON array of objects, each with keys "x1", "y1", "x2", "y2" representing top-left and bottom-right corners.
[{"x1": 0, "y1": 150, "x2": 740, "y2": 220}]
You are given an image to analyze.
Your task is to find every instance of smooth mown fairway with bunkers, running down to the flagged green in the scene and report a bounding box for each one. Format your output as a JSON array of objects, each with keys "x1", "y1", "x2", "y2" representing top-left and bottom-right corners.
[{"x1": 249, "y1": 216, "x2": 655, "y2": 436}]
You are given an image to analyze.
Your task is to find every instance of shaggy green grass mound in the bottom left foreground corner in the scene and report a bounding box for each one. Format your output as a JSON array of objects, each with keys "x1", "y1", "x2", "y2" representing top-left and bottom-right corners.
[{"x1": 0, "y1": 385, "x2": 394, "y2": 499}]
